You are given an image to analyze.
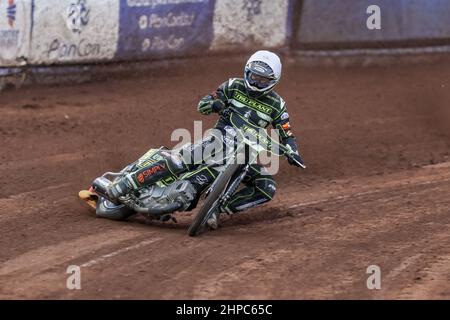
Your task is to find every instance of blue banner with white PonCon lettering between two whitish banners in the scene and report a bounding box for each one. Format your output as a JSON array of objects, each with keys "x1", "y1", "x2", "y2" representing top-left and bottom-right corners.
[{"x1": 116, "y1": 0, "x2": 215, "y2": 59}]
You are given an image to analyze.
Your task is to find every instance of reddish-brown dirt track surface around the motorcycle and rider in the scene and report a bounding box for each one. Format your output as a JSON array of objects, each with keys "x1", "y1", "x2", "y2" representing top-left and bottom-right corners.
[{"x1": 0, "y1": 57, "x2": 450, "y2": 299}]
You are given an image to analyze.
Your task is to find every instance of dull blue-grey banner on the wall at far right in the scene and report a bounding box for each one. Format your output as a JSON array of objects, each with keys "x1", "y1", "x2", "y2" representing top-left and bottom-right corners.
[{"x1": 297, "y1": 0, "x2": 450, "y2": 44}]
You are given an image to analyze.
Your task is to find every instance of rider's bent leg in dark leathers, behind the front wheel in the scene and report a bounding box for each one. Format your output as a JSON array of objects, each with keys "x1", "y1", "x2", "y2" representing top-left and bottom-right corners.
[{"x1": 207, "y1": 164, "x2": 276, "y2": 229}]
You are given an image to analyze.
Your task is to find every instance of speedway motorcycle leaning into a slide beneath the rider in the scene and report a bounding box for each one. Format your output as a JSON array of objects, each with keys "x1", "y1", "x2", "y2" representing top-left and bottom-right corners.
[{"x1": 79, "y1": 107, "x2": 306, "y2": 236}]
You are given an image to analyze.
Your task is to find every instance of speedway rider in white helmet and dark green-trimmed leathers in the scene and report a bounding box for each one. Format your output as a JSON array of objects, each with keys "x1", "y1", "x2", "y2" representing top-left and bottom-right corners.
[{"x1": 103, "y1": 51, "x2": 303, "y2": 229}]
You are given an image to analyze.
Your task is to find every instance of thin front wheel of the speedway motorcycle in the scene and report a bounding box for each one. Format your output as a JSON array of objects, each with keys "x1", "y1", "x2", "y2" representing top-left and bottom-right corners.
[{"x1": 188, "y1": 163, "x2": 240, "y2": 237}]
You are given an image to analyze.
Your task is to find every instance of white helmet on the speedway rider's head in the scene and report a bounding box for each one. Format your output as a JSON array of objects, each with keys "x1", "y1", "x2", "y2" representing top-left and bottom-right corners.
[{"x1": 244, "y1": 50, "x2": 282, "y2": 96}]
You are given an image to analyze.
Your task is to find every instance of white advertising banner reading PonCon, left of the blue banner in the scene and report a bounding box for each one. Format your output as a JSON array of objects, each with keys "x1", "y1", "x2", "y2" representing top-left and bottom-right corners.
[{"x1": 30, "y1": 0, "x2": 119, "y2": 64}]
